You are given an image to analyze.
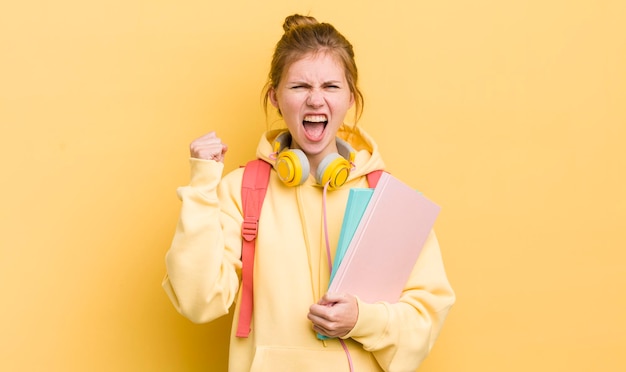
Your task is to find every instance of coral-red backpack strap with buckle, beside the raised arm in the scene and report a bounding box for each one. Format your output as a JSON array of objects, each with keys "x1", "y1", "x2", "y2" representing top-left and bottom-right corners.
[{"x1": 237, "y1": 159, "x2": 271, "y2": 337}]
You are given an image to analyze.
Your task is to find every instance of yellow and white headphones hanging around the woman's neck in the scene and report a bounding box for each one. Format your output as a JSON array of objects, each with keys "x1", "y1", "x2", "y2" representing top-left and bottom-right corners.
[{"x1": 274, "y1": 131, "x2": 355, "y2": 190}]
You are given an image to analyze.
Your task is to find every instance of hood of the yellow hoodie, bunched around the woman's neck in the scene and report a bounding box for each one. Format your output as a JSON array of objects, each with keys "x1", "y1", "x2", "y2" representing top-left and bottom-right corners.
[{"x1": 256, "y1": 125, "x2": 385, "y2": 181}]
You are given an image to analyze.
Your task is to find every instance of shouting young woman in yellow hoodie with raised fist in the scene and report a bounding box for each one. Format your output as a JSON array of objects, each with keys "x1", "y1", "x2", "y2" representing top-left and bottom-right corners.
[{"x1": 163, "y1": 15, "x2": 455, "y2": 372}]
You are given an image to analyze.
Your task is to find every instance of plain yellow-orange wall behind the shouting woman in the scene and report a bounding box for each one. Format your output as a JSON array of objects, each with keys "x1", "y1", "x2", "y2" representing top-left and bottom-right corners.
[{"x1": 0, "y1": 0, "x2": 626, "y2": 372}]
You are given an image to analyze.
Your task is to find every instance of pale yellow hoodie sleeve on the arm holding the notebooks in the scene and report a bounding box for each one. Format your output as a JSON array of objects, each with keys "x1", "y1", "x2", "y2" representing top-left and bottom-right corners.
[{"x1": 344, "y1": 232, "x2": 455, "y2": 371}]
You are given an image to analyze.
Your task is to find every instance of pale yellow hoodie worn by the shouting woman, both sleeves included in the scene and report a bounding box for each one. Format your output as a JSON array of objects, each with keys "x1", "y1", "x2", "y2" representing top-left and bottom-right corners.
[{"x1": 163, "y1": 126, "x2": 455, "y2": 372}]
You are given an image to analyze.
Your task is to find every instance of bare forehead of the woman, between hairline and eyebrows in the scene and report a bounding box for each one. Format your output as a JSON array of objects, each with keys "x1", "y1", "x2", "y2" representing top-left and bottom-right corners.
[{"x1": 284, "y1": 52, "x2": 345, "y2": 80}]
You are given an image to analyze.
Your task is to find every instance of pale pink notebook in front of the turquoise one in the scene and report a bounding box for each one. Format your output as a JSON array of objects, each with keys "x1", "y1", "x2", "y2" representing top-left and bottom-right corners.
[{"x1": 328, "y1": 173, "x2": 440, "y2": 303}]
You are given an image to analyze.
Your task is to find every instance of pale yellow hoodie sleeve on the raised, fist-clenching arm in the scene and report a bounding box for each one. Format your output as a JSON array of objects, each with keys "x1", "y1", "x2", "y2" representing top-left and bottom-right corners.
[{"x1": 162, "y1": 159, "x2": 241, "y2": 323}]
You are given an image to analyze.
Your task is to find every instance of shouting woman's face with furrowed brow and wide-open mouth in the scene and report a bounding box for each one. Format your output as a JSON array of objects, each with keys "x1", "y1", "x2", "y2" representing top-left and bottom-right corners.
[{"x1": 269, "y1": 53, "x2": 354, "y2": 165}]
